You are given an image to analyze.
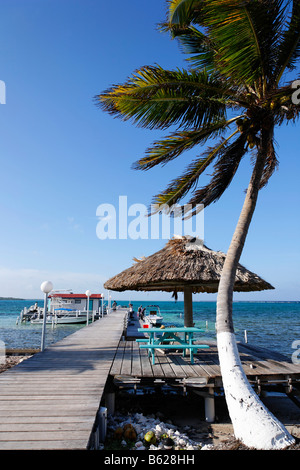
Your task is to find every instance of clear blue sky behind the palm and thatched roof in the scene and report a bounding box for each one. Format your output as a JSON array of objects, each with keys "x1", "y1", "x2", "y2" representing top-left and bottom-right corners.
[{"x1": 0, "y1": 0, "x2": 300, "y2": 300}]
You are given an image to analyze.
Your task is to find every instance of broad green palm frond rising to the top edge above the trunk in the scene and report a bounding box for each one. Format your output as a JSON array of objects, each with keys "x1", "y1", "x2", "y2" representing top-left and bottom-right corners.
[{"x1": 204, "y1": 0, "x2": 284, "y2": 83}]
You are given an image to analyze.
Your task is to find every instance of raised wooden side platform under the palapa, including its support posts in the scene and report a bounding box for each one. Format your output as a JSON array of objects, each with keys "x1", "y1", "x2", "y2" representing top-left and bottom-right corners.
[{"x1": 110, "y1": 340, "x2": 300, "y2": 423}]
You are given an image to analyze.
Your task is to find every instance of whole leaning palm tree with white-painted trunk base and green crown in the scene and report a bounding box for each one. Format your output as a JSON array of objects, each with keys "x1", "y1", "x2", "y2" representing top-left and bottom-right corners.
[{"x1": 96, "y1": 0, "x2": 300, "y2": 449}]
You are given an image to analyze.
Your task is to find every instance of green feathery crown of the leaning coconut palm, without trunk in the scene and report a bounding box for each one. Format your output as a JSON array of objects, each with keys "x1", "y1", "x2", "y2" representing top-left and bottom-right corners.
[{"x1": 96, "y1": 0, "x2": 300, "y2": 217}]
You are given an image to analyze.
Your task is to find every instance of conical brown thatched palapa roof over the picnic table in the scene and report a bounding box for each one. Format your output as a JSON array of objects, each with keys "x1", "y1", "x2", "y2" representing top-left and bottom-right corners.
[{"x1": 104, "y1": 237, "x2": 274, "y2": 293}]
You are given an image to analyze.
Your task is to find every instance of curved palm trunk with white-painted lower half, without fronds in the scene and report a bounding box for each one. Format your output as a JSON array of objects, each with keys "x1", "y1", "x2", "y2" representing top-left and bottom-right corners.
[{"x1": 217, "y1": 131, "x2": 295, "y2": 450}]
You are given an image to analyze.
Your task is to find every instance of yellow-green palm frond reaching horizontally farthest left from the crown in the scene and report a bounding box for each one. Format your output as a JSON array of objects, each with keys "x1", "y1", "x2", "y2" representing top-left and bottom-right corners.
[{"x1": 96, "y1": 66, "x2": 236, "y2": 129}]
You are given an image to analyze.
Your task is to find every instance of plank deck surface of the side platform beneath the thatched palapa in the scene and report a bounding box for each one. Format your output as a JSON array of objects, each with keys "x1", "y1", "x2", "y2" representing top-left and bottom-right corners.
[{"x1": 110, "y1": 341, "x2": 300, "y2": 386}]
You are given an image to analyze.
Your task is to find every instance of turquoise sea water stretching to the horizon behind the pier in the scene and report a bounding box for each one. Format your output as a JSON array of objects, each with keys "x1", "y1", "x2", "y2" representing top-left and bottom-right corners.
[{"x1": 0, "y1": 299, "x2": 300, "y2": 358}]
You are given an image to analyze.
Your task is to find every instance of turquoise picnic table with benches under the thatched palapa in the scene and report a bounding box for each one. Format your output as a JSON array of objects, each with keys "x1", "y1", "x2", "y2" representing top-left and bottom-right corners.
[{"x1": 136, "y1": 327, "x2": 209, "y2": 364}]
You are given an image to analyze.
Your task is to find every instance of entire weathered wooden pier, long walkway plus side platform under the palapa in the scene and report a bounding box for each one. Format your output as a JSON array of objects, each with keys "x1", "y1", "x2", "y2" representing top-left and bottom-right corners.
[{"x1": 0, "y1": 309, "x2": 300, "y2": 450}]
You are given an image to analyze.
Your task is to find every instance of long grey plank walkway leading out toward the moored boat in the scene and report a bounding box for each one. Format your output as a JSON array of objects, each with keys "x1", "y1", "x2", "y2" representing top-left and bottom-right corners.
[{"x1": 0, "y1": 311, "x2": 125, "y2": 450}]
